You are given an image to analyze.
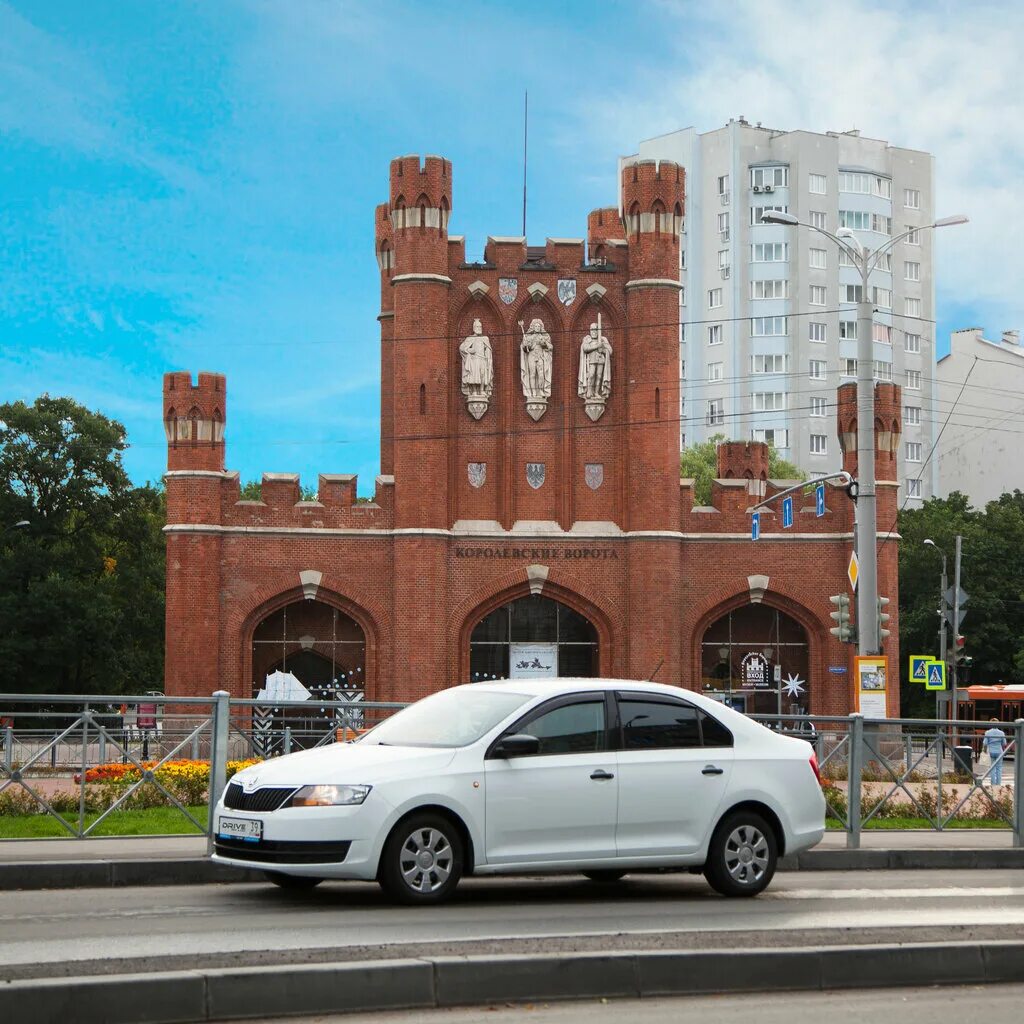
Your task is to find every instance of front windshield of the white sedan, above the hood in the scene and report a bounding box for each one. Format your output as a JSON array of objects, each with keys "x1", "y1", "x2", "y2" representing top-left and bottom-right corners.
[{"x1": 361, "y1": 686, "x2": 530, "y2": 746}]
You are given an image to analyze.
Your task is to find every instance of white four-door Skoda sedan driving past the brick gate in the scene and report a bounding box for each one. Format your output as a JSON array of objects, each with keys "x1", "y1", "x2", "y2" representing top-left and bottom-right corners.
[{"x1": 213, "y1": 679, "x2": 825, "y2": 903}]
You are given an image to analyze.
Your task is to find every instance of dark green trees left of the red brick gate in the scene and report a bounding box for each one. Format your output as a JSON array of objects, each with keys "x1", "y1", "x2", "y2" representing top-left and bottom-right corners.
[{"x1": 0, "y1": 395, "x2": 166, "y2": 693}]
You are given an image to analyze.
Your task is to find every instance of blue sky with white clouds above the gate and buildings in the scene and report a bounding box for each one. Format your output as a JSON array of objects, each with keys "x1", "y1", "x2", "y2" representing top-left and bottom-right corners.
[{"x1": 0, "y1": 0, "x2": 1024, "y2": 494}]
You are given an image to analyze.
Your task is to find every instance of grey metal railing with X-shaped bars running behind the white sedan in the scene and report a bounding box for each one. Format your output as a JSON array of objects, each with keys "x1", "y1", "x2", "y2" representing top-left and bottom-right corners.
[{"x1": 0, "y1": 691, "x2": 1024, "y2": 848}]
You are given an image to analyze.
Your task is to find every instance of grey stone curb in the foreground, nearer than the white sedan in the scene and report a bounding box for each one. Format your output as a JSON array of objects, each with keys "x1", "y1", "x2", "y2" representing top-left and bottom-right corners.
[{"x1": 0, "y1": 941, "x2": 1024, "y2": 1024}]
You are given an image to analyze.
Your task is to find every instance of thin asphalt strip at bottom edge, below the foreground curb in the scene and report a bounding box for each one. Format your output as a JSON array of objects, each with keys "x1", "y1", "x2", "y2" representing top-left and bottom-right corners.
[{"x1": 253, "y1": 985, "x2": 1024, "y2": 1024}]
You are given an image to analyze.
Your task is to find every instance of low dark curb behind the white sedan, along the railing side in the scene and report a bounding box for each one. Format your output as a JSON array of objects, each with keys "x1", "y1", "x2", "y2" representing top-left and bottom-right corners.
[{"x1": 0, "y1": 848, "x2": 1024, "y2": 890}]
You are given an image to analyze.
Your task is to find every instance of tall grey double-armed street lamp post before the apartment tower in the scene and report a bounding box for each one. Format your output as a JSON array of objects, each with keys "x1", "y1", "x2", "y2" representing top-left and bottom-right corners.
[{"x1": 761, "y1": 210, "x2": 967, "y2": 654}]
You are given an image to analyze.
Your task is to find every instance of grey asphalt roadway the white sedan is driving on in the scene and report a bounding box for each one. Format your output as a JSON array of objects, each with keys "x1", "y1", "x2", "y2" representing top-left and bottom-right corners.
[{"x1": 6, "y1": 870, "x2": 1024, "y2": 979}]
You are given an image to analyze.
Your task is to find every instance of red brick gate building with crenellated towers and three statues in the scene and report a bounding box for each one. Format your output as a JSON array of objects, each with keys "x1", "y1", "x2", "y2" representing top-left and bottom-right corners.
[{"x1": 157, "y1": 151, "x2": 900, "y2": 714}]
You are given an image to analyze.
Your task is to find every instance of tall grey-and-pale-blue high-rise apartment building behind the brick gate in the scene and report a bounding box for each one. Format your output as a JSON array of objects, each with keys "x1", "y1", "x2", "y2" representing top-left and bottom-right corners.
[{"x1": 624, "y1": 118, "x2": 935, "y2": 505}]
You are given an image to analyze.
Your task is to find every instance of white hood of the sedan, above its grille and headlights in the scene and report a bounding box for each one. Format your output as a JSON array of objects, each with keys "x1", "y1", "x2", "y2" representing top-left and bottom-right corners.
[{"x1": 231, "y1": 743, "x2": 456, "y2": 790}]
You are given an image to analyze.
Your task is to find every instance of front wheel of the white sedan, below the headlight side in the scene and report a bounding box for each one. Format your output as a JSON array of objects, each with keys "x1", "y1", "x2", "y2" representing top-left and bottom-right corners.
[{"x1": 378, "y1": 813, "x2": 463, "y2": 904}]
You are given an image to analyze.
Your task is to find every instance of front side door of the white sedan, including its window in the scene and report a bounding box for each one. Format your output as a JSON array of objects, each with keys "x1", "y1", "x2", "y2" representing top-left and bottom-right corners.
[{"x1": 484, "y1": 693, "x2": 618, "y2": 864}]
